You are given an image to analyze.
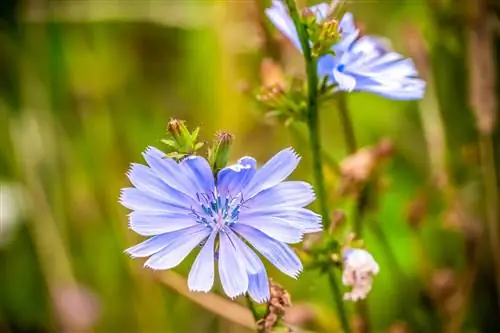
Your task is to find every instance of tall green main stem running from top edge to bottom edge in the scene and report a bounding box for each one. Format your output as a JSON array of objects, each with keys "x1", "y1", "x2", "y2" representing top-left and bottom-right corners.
[{"x1": 285, "y1": 0, "x2": 351, "y2": 333}]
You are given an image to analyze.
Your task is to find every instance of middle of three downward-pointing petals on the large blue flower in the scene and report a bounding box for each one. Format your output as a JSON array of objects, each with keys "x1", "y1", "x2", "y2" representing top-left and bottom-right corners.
[{"x1": 219, "y1": 232, "x2": 248, "y2": 298}]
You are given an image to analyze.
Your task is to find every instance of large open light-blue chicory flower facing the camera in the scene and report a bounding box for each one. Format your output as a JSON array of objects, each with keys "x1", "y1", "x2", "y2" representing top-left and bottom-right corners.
[{"x1": 120, "y1": 148, "x2": 322, "y2": 302}]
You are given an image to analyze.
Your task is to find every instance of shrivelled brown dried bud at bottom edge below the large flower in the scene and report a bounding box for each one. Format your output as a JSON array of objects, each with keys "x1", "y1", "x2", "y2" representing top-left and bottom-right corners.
[{"x1": 257, "y1": 280, "x2": 292, "y2": 333}]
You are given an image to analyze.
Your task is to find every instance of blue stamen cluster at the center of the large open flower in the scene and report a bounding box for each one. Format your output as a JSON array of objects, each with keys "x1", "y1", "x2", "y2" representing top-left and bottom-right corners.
[{"x1": 192, "y1": 189, "x2": 242, "y2": 230}]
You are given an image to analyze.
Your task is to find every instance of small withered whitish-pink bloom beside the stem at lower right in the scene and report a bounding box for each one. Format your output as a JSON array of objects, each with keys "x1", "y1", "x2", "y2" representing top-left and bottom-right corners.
[{"x1": 342, "y1": 248, "x2": 379, "y2": 301}]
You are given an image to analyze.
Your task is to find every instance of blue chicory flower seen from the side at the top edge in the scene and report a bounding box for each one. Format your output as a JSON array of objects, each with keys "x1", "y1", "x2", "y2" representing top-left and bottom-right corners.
[{"x1": 266, "y1": 0, "x2": 425, "y2": 100}]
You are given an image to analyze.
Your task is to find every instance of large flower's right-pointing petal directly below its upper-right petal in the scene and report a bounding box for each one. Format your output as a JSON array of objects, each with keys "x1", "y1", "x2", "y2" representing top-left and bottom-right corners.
[{"x1": 245, "y1": 181, "x2": 315, "y2": 209}]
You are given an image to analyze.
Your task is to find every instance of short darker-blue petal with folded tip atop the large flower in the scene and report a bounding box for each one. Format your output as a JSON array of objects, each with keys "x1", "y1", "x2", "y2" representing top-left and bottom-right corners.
[{"x1": 217, "y1": 157, "x2": 257, "y2": 196}]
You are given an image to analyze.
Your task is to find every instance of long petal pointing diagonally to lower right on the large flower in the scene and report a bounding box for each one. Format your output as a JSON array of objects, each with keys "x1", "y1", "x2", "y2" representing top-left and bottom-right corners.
[{"x1": 232, "y1": 223, "x2": 302, "y2": 278}]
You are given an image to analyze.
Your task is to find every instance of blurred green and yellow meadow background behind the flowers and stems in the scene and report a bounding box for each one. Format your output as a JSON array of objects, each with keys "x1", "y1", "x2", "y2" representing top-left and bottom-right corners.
[{"x1": 0, "y1": 0, "x2": 500, "y2": 333}]
